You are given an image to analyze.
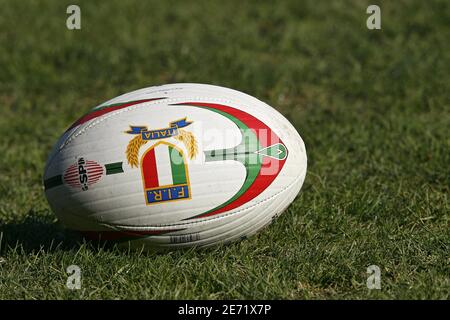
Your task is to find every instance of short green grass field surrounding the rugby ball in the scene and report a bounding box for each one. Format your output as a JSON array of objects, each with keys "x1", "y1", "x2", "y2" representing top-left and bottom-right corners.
[{"x1": 0, "y1": 0, "x2": 450, "y2": 299}]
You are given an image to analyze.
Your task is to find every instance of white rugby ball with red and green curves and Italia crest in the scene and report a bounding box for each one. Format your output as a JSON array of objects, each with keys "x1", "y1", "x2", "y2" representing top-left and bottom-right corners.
[{"x1": 44, "y1": 84, "x2": 307, "y2": 248}]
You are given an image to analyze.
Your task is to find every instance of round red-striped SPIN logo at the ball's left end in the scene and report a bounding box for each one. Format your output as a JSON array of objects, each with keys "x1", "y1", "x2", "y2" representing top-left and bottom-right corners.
[{"x1": 63, "y1": 157, "x2": 104, "y2": 191}]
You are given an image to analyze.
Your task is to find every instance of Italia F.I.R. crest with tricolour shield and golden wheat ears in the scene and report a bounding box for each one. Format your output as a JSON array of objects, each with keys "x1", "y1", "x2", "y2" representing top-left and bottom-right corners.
[{"x1": 126, "y1": 118, "x2": 198, "y2": 205}]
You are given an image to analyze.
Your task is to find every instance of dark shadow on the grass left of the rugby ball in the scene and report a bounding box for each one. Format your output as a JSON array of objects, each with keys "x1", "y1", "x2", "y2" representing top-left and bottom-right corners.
[{"x1": 0, "y1": 216, "x2": 83, "y2": 254}]
